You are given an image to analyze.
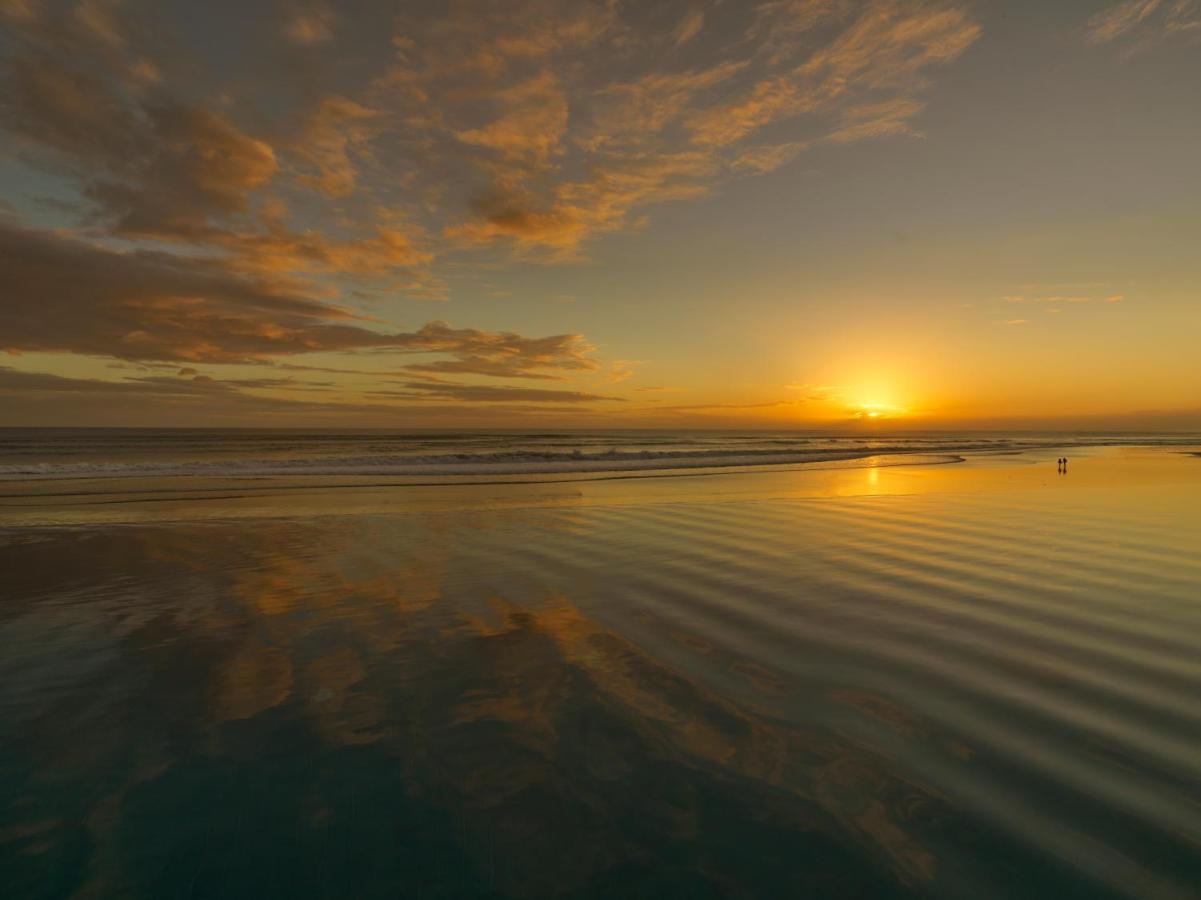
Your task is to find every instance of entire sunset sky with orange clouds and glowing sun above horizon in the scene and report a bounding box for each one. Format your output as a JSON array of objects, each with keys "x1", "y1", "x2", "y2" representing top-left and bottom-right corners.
[{"x1": 0, "y1": 0, "x2": 1201, "y2": 430}]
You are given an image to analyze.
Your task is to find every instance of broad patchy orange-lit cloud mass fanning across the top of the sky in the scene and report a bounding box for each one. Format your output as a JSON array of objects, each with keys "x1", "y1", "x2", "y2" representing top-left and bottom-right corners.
[{"x1": 4, "y1": 0, "x2": 979, "y2": 270}]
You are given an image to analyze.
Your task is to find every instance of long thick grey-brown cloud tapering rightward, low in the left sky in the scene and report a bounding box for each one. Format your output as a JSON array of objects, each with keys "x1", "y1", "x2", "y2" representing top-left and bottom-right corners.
[{"x1": 0, "y1": 222, "x2": 596, "y2": 371}]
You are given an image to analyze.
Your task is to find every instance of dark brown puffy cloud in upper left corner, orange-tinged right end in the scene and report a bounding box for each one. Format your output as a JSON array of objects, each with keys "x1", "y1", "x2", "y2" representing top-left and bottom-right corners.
[{"x1": 5, "y1": 21, "x2": 277, "y2": 236}]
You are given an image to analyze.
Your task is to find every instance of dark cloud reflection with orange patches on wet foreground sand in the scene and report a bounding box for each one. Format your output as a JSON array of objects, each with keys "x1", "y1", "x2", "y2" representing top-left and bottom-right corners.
[{"x1": 4, "y1": 529, "x2": 934, "y2": 896}]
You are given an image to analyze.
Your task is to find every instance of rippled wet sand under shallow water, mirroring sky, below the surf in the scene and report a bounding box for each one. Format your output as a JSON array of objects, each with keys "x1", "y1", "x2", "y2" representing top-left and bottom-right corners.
[{"x1": 0, "y1": 448, "x2": 1201, "y2": 898}]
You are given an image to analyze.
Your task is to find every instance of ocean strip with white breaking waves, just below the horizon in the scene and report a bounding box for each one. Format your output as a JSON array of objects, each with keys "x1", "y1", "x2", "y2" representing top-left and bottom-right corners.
[{"x1": 0, "y1": 428, "x2": 1186, "y2": 479}]
